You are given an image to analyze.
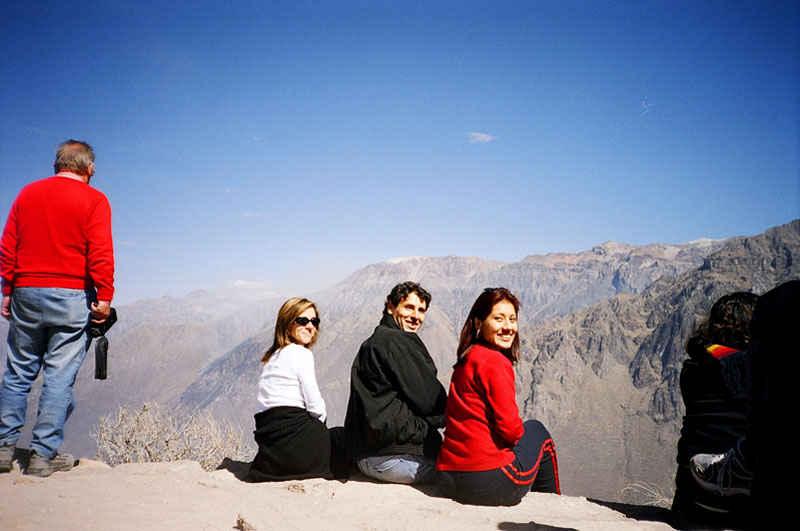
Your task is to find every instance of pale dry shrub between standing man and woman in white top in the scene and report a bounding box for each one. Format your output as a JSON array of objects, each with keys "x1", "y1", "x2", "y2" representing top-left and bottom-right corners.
[{"x1": 90, "y1": 402, "x2": 250, "y2": 470}]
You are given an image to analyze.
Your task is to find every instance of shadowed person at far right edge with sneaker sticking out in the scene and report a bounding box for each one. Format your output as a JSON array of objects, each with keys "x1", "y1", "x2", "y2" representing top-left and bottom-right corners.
[{"x1": 690, "y1": 280, "x2": 800, "y2": 529}]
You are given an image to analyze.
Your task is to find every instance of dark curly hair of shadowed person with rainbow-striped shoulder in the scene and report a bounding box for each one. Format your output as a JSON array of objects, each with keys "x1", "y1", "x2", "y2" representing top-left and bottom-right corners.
[{"x1": 686, "y1": 291, "x2": 758, "y2": 350}]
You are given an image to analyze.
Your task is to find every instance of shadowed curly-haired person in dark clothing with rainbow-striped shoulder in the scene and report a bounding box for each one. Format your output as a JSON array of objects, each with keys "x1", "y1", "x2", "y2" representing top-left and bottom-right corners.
[{"x1": 672, "y1": 292, "x2": 758, "y2": 525}]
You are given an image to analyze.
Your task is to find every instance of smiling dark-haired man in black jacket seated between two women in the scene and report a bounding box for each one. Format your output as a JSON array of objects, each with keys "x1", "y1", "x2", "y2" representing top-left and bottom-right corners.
[{"x1": 344, "y1": 282, "x2": 447, "y2": 483}]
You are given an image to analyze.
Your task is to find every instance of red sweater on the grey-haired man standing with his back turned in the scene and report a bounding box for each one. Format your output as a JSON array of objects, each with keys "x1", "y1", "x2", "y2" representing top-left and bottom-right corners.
[{"x1": 0, "y1": 176, "x2": 114, "y2": 301}]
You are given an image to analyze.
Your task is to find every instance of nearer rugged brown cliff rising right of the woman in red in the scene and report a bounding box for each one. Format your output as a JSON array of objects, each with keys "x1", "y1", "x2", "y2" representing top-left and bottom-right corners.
[{"x1": 517, "y1": 220, "x2": 800, "y2": 497}]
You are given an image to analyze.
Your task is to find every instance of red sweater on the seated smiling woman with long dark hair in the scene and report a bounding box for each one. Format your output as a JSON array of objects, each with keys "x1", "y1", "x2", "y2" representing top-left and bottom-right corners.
[{"x1": 436, "y1": 345, "x2": 524, "y2": 472}]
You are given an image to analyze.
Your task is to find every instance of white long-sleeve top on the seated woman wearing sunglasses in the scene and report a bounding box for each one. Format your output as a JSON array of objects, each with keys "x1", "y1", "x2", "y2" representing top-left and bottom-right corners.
[{"x1": 258, "y1": 343, "x2": 327, "y2": 422}]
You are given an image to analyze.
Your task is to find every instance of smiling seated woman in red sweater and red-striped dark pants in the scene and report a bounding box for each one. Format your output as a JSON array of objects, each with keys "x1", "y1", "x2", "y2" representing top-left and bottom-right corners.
[{"x1": 436, "y1": 288, "x2": 561, "y2": 505}]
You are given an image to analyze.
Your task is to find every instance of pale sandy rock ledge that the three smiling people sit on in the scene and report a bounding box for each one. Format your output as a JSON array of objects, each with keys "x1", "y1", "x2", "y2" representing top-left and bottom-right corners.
[{"x1": 0, "y1": 456, "x2": 671, "y2": 531}]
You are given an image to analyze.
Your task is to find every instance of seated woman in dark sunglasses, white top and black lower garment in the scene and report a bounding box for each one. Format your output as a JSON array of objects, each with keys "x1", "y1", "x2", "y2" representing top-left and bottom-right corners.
[{"x1": 250, "y1": 298, "x2": 331, "y2": 481}]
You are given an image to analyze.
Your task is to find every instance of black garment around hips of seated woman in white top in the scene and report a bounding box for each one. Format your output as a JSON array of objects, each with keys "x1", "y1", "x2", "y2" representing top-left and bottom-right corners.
[{"x1": 249, "y1": 406, "x2": 333, "y2": 481}]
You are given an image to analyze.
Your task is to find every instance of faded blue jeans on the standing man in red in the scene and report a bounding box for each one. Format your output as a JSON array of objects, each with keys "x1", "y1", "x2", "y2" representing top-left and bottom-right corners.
[{"x1": 0, "y1": 288, "x2": 94, "y2": 457}]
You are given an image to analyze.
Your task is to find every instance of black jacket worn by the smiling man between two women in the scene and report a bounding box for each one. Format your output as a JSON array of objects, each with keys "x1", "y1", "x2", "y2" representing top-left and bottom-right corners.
[{"x1": 344, "y1": 312, "x2": 447, "y2": 459}]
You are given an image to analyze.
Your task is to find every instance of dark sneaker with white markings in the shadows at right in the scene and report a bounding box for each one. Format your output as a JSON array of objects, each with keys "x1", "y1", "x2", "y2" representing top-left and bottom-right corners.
[{"x1": 689, "y1": 449, "x2": 753, "y2": 496}]
